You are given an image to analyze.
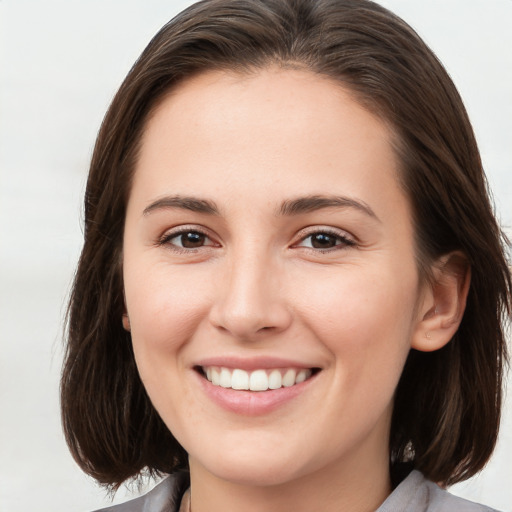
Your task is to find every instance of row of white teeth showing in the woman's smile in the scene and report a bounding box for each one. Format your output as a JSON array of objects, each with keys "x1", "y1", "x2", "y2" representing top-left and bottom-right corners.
[{"x1": 203, "y1": 366, "x2": 312, "y2": 391}]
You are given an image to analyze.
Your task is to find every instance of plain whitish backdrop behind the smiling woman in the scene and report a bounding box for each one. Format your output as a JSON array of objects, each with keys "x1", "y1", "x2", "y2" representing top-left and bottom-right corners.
[{"x1": 0, "y1": 0, "x2": 512, "y2": 512}]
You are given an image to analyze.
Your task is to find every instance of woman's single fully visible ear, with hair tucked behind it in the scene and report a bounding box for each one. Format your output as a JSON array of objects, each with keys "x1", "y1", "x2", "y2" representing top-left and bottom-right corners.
[{"x1": 411, "y1": 251, "x2": 471, "y2": 352}]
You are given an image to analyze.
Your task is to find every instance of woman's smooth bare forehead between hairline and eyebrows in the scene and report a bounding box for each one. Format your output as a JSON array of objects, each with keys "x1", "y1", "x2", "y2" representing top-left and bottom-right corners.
[{"x1": 132, "y1": 68, "x2": 408, "y2": 226}]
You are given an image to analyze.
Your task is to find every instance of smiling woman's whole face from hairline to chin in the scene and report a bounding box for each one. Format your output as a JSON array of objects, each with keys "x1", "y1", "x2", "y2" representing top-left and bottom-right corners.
[{"x1": 123, "y1": 69, "x2": 422, "y2": 485}]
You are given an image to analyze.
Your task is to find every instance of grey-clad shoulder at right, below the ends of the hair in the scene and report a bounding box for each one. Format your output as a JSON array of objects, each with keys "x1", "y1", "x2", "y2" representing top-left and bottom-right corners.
[{"x1": 376, "y1": 471, "x2": 497, "y2": 512}]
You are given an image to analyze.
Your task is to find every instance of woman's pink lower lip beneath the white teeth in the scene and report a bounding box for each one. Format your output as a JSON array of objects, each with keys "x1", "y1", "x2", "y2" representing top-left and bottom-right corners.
[{"x1": 194, "y1": 371, "x2": 317, "y2": 416}]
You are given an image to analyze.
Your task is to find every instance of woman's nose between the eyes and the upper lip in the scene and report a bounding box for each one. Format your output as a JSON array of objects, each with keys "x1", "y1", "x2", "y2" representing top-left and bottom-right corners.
[{"x1": 210, "y1": 252, "x2": 292, "y2": 341}]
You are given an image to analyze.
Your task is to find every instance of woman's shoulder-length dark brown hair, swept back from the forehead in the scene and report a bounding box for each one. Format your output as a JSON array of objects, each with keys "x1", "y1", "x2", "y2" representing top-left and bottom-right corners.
[{"x1": 61, "y1": 0, "x2": 512, "y2": 487}]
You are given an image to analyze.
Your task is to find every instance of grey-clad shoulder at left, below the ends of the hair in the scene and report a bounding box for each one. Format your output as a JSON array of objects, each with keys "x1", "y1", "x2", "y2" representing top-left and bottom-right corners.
[{"x1": 91, "y1": 473, "x2": 188, "y2": 512}]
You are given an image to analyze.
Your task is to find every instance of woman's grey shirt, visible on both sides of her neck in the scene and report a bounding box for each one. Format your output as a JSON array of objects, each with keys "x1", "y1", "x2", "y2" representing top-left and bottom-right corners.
[{"x1": 97, "y1": 471, "x2": 497, "y2": 512}]
